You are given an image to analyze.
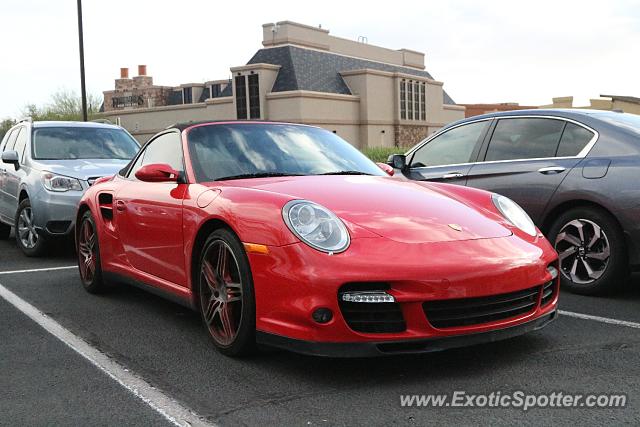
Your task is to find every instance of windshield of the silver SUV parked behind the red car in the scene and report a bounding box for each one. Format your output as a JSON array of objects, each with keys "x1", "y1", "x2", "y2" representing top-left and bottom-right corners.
[{"x1": 33, "y1": 127, "x2": 139, "y2": 160}]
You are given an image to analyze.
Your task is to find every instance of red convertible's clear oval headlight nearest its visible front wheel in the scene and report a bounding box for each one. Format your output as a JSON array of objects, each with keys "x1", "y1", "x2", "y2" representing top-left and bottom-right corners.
[{"x1": 282, "y1": 200, "x2": 350, "y2": 253}]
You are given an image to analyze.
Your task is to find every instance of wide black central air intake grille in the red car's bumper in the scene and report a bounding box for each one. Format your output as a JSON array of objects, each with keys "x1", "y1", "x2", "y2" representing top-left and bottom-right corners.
[{"x1": 422, "y1": 286, "x2": 541, "y2": 328}]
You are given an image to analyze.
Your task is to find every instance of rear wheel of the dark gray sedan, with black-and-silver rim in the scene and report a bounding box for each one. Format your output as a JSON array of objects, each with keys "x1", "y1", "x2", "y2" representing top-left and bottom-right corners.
[{"x1": 548, "y1": 207, "x2": 629, "y2": 295}]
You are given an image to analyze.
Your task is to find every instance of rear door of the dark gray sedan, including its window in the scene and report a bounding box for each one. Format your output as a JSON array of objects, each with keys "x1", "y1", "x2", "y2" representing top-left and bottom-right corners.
[{"x1": 467, "y1": 117, "x2": 597, "y2": 225}]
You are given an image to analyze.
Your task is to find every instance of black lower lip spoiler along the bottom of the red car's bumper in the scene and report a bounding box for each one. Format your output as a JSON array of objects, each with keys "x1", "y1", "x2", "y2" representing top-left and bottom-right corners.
[{"x1": 256, "y1": 310, "x2": 558, "y2": 357}]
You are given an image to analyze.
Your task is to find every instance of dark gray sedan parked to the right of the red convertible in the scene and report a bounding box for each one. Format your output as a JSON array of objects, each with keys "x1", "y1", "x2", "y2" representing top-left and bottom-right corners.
[{"x1": 389, "y1": 109, "x2": 640, "y2": 294}]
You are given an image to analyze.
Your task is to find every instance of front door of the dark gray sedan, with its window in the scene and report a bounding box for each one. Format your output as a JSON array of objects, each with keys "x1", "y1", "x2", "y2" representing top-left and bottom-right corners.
[{"x1": 405, "y1": 119, "x2": 491, "y2": 185}]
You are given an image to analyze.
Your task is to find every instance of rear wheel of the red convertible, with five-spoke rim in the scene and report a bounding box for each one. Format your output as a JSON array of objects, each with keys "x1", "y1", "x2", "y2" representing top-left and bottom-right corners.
[{"x1": 76, "y1": 211, "x2": 107, "y2": 294}]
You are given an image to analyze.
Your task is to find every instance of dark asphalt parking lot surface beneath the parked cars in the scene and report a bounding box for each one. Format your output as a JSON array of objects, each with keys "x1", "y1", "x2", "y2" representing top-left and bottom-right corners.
[{"x1": 0, "y1": 234, "x2": 640, "y2": 426}]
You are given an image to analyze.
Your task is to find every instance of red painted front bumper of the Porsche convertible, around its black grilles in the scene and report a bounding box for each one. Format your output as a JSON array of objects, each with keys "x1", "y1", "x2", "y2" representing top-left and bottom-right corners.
[{"x1": 248, "y1": 236, "x2": 559, "y2": 348}]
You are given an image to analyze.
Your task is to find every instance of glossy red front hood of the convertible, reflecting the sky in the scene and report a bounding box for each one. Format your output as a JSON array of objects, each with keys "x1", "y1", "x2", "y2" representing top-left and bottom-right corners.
[{"x1": 218, "y1": 176, "x2": 511, "y2": 243}]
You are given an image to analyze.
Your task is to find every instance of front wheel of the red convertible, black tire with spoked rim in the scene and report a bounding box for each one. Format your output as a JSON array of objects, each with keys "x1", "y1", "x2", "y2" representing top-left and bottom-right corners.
[{"x1": 193, "y1": 229, "x2": 256, "y2": 357}]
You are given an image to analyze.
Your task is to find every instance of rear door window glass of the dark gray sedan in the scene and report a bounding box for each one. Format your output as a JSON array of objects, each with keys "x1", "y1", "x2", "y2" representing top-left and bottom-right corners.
[{"x1": 485, "y1": 118, "x2": 565, "y2": 161}]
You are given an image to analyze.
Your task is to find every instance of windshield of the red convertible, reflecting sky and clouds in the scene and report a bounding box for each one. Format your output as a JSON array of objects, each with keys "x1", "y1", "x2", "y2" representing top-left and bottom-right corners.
[{"x1": 188, "y1": 124, "x2": 385, "y2": 182}]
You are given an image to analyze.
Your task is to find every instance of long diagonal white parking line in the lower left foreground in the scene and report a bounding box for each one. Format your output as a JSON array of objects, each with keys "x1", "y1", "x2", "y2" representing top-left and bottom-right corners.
[{"x1": 0, "y1": 284, "x2": 213, "y2": 426}]
